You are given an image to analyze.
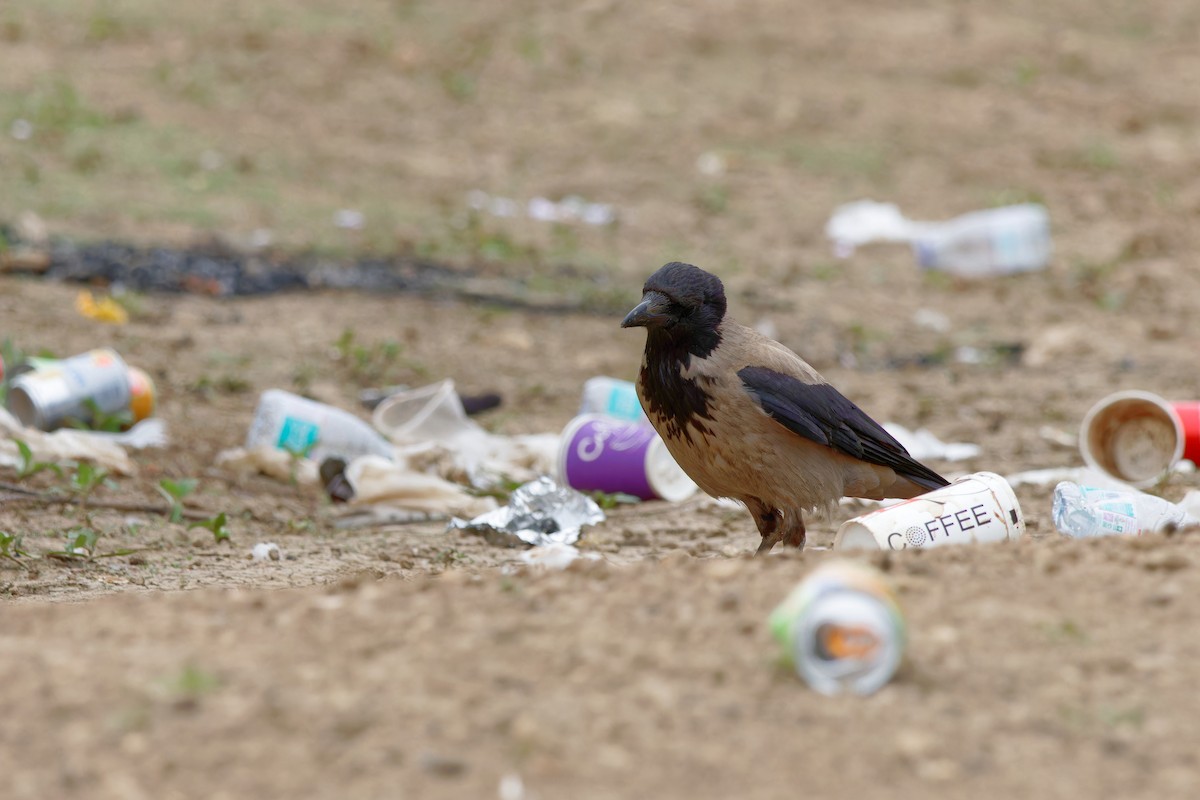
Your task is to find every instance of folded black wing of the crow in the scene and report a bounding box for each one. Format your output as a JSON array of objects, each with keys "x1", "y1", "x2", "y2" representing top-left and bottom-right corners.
[{"x1": 738, "y1": 367, "x2": 949, "y2": 489}]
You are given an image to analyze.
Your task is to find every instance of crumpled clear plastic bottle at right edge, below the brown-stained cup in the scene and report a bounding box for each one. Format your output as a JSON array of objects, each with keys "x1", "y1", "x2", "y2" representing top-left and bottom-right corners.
[{"x1": 1052, "y1": 481, "x2": 1200, "y2": 539}]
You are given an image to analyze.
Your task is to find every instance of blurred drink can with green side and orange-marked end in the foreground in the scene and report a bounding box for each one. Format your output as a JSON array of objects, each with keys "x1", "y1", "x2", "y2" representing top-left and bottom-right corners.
[{"x1": 769, "y1": 560, "x2": 906, "y2": 694}]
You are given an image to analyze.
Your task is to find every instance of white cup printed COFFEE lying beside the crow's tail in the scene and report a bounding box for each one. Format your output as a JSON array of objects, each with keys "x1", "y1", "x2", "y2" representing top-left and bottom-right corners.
[{"x1": 833, "y1": 473, "x2": 1025, "y2": 551}]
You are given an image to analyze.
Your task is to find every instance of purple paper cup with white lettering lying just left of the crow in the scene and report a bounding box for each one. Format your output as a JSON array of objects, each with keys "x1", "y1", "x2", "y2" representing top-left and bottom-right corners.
[{"x1": 558, "y1": 414, "x2": 696, "y2": 503}]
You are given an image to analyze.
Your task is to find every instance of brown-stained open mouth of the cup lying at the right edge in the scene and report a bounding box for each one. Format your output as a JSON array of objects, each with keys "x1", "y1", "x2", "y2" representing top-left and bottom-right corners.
[{"x1": 1079, "y1": 391, "x2": 1189, "y2": 488}]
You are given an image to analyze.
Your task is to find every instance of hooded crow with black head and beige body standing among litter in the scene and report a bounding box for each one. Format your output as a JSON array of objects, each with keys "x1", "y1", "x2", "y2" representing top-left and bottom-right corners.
[{"x1": 620, "y1": 261, "x2": 948, "y2": 553}]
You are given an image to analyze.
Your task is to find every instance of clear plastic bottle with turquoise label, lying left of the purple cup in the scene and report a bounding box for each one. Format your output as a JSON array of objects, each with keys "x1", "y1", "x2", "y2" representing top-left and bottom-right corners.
[{"x1": 246, "y1": 389, "x2": 395, "y2": 462}]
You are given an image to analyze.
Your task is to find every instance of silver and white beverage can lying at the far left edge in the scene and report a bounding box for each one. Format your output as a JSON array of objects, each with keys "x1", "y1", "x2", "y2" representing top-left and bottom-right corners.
[{"x1": 7, "y1": 348, "x2": 137, "y2": 431}]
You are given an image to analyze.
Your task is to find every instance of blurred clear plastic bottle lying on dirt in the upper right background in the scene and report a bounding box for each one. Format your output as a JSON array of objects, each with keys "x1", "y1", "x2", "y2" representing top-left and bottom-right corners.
[{"x1": 912, "y1": 203, "x2": 1051, "y2": 278}]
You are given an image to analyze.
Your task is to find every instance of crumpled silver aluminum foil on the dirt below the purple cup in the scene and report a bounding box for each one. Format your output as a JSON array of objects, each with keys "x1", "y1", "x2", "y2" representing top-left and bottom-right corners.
[{"x1": 449, "y1": 477, "x2": 605, "y2": 547}]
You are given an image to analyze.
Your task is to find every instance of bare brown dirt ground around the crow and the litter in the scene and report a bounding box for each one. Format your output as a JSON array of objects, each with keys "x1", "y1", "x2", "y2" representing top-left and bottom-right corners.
[{"x1": 0, "y1": 0, "x2": 1200, "y2": 800}]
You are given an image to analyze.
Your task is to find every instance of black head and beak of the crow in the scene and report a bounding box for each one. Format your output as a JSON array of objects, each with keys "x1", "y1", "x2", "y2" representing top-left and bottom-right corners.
[{"x1": 620, "y1": 261, "x2": 725, "y2": 356}]
